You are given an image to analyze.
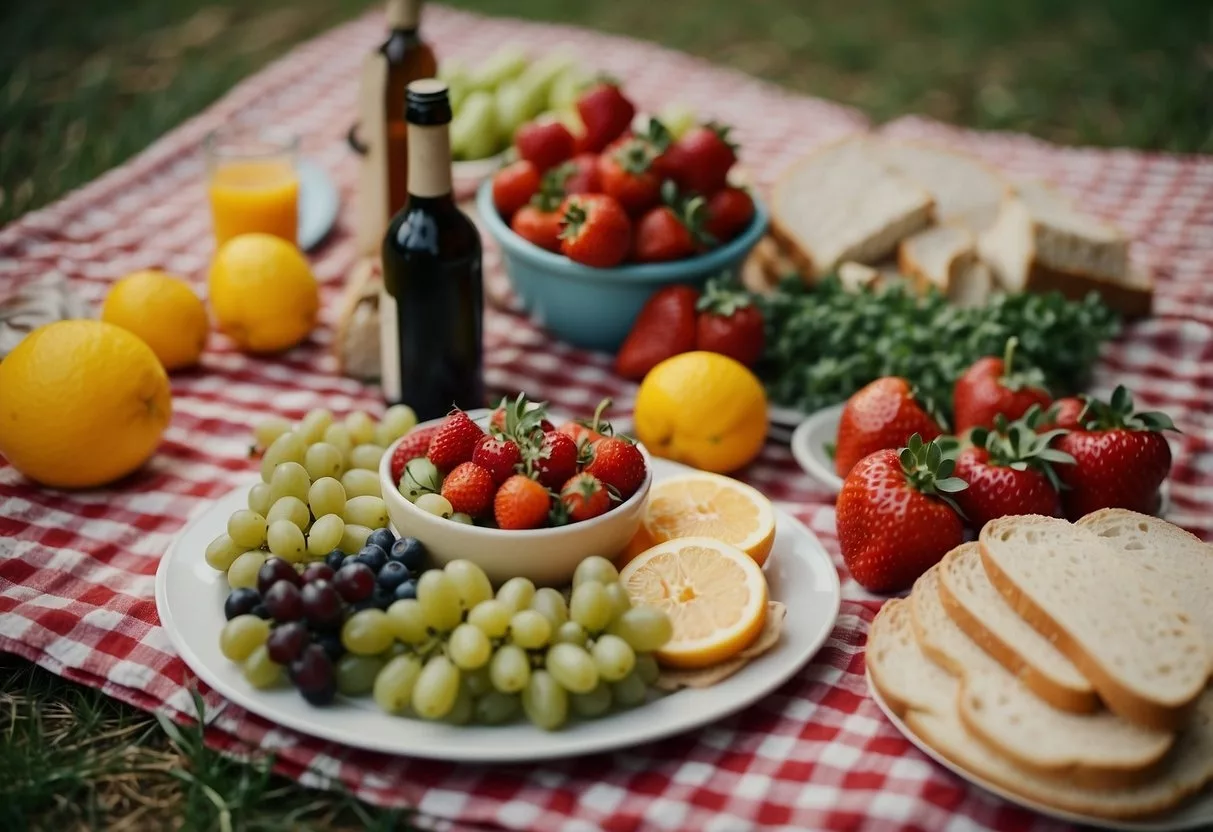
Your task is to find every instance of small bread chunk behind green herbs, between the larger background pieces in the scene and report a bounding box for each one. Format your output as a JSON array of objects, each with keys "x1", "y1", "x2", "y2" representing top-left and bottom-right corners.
[{"x1": 898, "y1": 226, "x2": 993, "y2": 307}]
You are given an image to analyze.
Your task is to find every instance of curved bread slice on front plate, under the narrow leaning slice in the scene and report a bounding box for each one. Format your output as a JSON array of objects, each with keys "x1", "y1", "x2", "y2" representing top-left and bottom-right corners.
[{"x1": 910, "y1": 560, "x2": 1174, "y2": 788}]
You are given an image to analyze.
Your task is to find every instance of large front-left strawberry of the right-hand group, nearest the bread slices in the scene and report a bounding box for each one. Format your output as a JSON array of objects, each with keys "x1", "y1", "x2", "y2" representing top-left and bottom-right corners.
[{"x1": 835, "y1": 434, "x2": 967, "y2": 592}]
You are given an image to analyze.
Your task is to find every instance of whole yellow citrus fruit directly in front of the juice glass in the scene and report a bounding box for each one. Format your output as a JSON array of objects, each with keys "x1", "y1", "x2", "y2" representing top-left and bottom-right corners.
[{"x1": 207, "y1": 234, "x2": 320, "y2": 353}]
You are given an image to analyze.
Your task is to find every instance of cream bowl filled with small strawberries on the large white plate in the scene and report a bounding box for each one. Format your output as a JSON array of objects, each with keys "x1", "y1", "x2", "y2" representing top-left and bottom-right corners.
[{"x1": 380, "y1": 395, "x2": 653, "y2": 586}]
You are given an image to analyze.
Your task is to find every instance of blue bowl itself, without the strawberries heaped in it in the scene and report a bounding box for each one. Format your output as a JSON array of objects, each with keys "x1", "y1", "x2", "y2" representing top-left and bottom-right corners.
[{"x1": 475, "y1": 179, "x2": 767, "y2": 352}]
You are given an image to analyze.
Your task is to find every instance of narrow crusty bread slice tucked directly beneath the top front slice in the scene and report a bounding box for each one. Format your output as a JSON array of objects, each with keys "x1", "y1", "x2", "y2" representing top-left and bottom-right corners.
[{"x1": 939, "y1": 543, "x2": 1100, "y2": 713}]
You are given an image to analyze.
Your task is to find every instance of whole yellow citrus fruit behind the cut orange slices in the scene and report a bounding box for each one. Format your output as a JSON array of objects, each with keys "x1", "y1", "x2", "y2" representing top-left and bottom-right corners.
[{"x1": 636, "y1": 352, "x2": 767, "y2": 474}]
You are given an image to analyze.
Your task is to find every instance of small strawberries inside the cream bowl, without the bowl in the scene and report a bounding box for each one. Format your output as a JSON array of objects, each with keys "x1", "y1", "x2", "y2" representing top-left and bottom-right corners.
[{"x1": 391, "y1": 395, "x2": 647, "y2": 529}]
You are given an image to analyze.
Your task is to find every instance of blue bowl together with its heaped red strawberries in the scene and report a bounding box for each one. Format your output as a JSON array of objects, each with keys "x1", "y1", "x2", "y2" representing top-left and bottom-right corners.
[{"x1": 477, "y1": 81, "x2": 767, "y2": 351}]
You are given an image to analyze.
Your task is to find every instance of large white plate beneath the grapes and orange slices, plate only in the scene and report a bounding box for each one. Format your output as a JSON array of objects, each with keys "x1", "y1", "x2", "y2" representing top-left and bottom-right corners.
[{"x1": 155, "y1": 460, "x2": 842, "y2": 763}]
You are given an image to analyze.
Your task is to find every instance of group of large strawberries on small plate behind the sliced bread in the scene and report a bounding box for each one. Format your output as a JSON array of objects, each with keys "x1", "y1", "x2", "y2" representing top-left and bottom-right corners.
[{"x1": 835, "y1": 338, "x2": 1175, "y2": 592}]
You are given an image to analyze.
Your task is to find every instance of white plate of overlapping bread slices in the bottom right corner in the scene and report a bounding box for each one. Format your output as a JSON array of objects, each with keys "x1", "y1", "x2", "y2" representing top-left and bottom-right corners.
[{"x1": 866, "y1": 509, "x2": 1213, "y2": 832}]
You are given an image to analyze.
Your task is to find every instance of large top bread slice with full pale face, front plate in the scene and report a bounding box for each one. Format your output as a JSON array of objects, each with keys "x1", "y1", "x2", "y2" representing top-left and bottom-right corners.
[{"x1": 979, "y1": 515, "x2": 1211, "y2": 730}]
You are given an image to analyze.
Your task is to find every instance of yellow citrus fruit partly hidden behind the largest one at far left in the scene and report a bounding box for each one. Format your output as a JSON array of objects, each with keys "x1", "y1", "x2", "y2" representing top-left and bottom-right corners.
[{"x1": 101, "y1": 270, "x2": 211, "y2": 370}]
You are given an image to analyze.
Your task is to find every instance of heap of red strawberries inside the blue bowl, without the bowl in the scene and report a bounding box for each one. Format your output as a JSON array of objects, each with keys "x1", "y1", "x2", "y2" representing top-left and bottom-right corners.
[{"x1": 492, "y1": 81, "x2": 754, "y2": 268}]
